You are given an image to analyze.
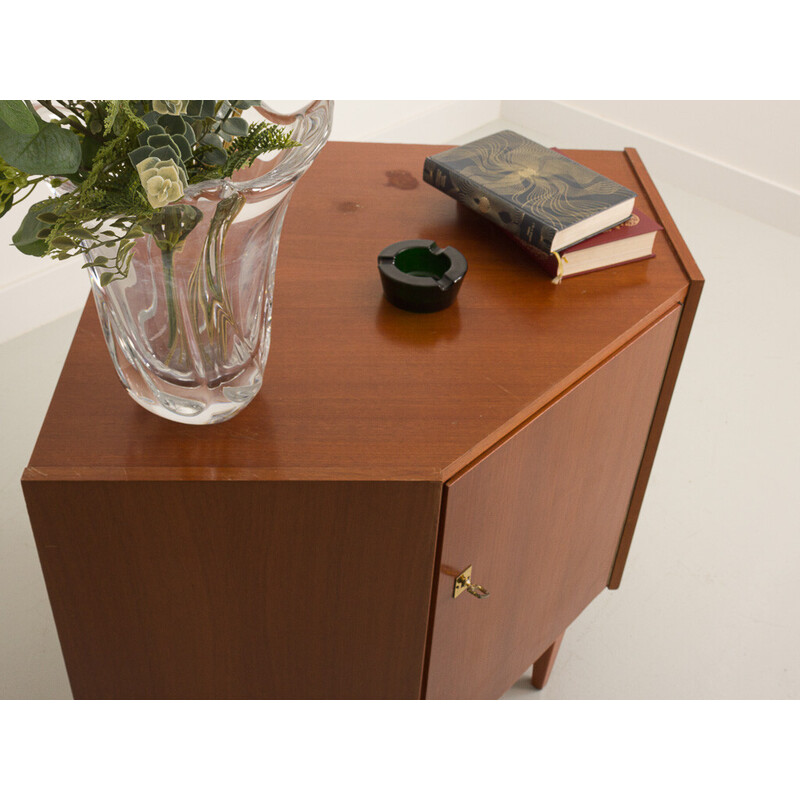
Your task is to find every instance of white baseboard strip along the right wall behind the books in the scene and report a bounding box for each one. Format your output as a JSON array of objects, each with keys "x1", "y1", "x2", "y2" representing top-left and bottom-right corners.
[{"x1": 501, "y1": 100, "x2": 800, "y2": 236}]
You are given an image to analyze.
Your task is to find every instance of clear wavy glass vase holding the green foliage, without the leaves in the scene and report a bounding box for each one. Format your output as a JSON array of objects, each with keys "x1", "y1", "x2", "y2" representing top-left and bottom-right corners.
[{"x1": 83, "y1": 101, "x2": 333, "y2": 425}]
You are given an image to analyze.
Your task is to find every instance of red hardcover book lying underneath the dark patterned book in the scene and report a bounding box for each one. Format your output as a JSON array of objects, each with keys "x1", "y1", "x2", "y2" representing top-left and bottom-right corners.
[{"x1": 509, "y1": 208, "x2": 662, "y2": 282}]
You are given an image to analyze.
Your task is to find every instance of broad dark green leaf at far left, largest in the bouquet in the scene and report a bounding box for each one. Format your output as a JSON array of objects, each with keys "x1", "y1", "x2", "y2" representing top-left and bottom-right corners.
[{"x1": 0, "y1": 120, "x2": 81, "y2": 175}]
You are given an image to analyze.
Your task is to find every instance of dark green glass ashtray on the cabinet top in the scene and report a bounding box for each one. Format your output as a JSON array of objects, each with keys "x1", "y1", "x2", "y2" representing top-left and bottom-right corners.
[{"x1": 378, "y1": 239, "x2": 467, "y2": 313}]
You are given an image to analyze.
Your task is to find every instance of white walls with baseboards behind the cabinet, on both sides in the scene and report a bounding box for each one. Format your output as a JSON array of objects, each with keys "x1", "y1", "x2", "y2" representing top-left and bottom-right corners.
[{"x1": 0, "y1": 100, "x2": 800, "y2": 342}]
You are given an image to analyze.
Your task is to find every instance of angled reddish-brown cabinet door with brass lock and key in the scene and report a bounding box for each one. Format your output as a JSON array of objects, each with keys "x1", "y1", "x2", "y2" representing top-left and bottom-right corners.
[{"x1": 426, "y1": 307, "x2": 680, "y2": 699}]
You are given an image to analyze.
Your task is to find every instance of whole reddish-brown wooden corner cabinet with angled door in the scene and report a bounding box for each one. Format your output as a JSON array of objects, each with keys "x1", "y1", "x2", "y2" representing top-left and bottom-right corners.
[{"x1": 23, "y1": 142, "x2": 703, "y2": 699}]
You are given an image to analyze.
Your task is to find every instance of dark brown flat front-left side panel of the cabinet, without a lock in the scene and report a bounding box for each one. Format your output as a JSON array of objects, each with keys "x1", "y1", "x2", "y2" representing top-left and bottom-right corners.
[{"x1": 24, "y1": 481, "x2": 441, "y2": 699}]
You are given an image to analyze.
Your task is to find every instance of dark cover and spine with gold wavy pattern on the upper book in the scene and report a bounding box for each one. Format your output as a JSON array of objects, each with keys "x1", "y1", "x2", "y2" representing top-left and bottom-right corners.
[{"x1": 423, "y1": 131, "x2": 636, "y2": 253}]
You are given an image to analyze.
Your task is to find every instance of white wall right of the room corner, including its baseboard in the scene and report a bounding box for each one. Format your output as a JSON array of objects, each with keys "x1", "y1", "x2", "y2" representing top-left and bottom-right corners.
[{"x1": 501, "y1": 100, "x2": 800, "y2": 234}]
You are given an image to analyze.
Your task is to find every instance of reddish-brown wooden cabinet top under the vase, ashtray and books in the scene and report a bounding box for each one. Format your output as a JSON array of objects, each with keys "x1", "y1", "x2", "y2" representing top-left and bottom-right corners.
[{"x1": 25, "y1": 142, "x2": 699, "y2": 481}]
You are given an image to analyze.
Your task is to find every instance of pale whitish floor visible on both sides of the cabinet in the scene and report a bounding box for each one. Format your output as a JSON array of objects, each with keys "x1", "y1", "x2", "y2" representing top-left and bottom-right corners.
[{"x1": 0, "y1": 120, "x2": 800, "y2": 700}]
